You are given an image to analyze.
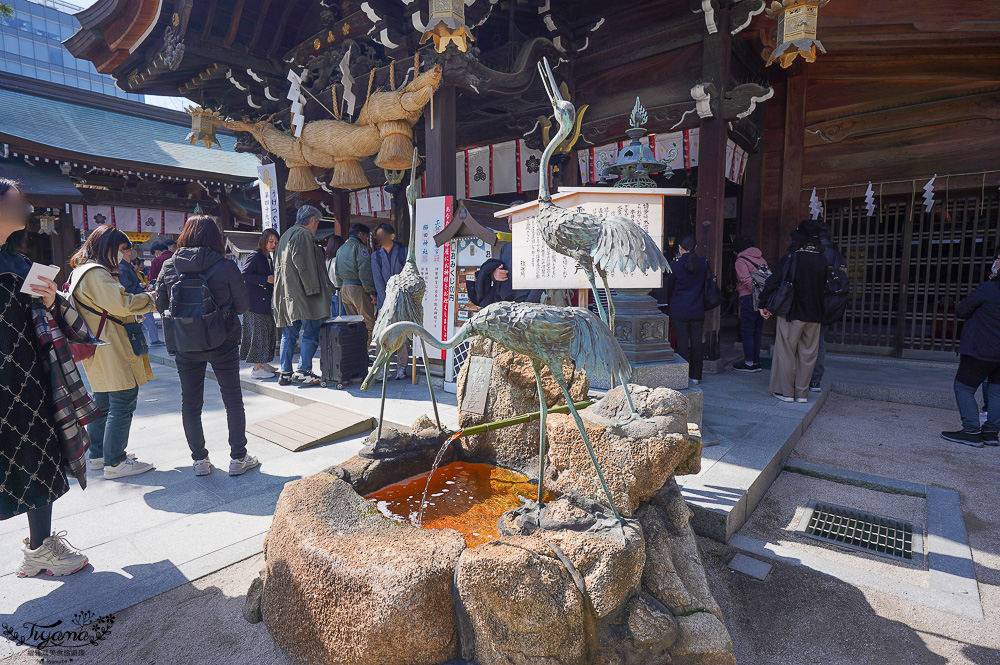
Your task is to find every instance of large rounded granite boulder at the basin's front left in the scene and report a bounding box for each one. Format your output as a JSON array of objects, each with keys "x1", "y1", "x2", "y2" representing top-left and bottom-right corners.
[{"x1": 261, "y1": 473, "x2": 465, "y2": 665}]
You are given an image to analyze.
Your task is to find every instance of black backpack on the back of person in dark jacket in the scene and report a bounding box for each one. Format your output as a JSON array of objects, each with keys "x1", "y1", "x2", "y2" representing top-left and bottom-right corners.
[{"x1": 163, "y1": 259, "x2": 232, "y2": 352}]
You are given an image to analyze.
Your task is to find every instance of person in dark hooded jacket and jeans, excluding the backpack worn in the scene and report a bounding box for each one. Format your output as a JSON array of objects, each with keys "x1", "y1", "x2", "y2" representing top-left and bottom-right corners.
[{"x1": 156, "y1": 215, "x2": 259, "y2": 476}]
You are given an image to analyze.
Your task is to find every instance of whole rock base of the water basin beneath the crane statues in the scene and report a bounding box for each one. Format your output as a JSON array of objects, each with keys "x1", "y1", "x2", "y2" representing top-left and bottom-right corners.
[{"x1": 250, "y1": 387, "x2": 735, "y2": 665}]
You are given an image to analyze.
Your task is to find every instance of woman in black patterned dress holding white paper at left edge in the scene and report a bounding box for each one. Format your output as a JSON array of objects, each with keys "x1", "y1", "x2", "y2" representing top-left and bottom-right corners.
[{"x1": 0, "y1": 178, "x2": 87, "y2": 577}]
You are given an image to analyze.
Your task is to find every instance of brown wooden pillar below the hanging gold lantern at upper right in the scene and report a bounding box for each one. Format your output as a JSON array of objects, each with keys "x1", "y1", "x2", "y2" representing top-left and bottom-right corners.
[{"x1": 778, "y1": 66, "x2": 806, "y2": 235}]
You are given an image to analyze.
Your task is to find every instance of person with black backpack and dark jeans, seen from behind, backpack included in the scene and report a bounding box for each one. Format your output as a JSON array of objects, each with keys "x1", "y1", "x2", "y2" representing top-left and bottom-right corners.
[{"x1": 156, "y1": 215, "x2": 260, "y2": 476}]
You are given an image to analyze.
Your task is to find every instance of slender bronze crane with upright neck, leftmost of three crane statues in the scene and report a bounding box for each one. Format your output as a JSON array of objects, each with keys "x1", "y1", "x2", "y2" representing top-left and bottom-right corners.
[{"x1": 361, "y1": 148, "x2": 443, "y2": 441}]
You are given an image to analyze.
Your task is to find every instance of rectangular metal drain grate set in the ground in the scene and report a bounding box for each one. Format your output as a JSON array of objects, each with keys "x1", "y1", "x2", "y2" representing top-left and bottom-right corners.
[{"x1": 798, "y1": 501, "x2": 919, "y2": 561}]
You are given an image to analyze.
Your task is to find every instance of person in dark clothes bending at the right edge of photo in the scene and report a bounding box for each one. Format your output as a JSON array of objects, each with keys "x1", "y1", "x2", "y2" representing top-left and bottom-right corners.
[{"x1": 941, "y1": 253, "x2": 1000, "y2": 448}]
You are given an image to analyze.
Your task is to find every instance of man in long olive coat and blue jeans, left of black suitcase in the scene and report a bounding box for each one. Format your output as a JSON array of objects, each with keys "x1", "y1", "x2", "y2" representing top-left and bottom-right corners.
[{"x1": 274, "y1": 205, "x2": 333, "y2": 386}]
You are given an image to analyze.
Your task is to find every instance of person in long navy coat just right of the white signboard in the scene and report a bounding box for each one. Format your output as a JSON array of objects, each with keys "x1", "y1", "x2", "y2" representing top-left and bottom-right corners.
[{"x1": 663, "y1": 235, "x2": 708, "y2": 384}]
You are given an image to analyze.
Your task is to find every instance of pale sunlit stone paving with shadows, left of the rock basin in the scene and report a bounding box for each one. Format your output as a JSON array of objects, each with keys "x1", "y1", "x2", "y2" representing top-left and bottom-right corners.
[{"x1": 0, "y1": 365, "x2": 363, "y2": 662}]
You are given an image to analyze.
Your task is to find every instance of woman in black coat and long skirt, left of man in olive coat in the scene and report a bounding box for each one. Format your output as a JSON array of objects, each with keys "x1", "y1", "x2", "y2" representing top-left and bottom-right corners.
[{"x1": 240, "y1": 229, "x2": 278, "y2": 379}]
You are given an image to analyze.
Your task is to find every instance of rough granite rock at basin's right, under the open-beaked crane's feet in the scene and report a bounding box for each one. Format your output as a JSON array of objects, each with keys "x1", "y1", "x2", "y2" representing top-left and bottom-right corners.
[{"x1": 545, "y1": 385, "x2": 701, "y2": 517}]
